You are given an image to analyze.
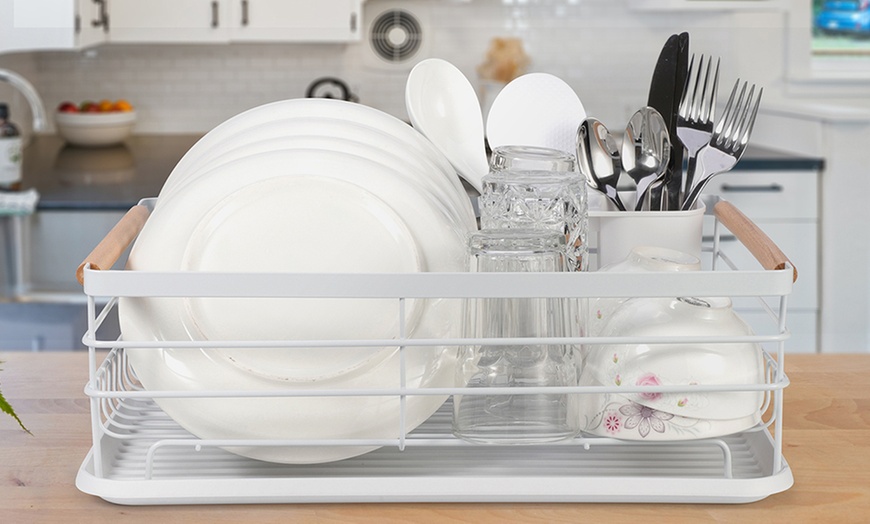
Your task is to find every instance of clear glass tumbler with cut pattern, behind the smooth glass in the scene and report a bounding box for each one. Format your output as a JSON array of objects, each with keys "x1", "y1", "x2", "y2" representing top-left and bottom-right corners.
[{"x1": 479, "y1": 146, "x2": 589, "y2": 271}]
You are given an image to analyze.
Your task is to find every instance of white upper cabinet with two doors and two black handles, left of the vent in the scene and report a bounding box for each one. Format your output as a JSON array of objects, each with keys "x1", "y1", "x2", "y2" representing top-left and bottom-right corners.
[{"x1": 109, "y1": 0, "x2": 362, "y2": 43}]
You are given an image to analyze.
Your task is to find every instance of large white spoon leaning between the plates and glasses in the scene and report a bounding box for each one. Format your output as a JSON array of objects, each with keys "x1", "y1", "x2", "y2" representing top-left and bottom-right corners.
[{"x1": 405, "y1": 58, "x2": 489, "y2": 193}]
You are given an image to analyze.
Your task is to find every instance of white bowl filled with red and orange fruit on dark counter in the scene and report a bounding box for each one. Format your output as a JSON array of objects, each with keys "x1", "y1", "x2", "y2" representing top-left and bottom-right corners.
[{"x1": 54, "y1": 100, "x2": 136, "y2": 147}]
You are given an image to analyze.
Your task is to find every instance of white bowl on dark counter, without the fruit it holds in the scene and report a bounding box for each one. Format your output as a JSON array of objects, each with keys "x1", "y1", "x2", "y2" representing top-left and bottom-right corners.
[{"x1": 54, "y1": 111, "x2": 136, "y2": 147}]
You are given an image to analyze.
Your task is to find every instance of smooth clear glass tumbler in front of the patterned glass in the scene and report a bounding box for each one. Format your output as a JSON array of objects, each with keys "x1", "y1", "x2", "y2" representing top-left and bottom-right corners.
[{"x1": 453, "y1": 229, "x2": 580, "y2": 444}]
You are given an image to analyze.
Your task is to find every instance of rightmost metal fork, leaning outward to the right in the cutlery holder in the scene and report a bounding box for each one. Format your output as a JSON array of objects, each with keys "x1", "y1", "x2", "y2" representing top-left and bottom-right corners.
[{"x1": 682, "y1": 78, "x2": 764, "y2": 211}]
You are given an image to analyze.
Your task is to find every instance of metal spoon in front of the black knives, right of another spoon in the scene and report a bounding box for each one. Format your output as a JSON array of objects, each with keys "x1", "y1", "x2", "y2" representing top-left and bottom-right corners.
[{"x1": 622, "y1": 106, "x2": 671, "y2": 211}]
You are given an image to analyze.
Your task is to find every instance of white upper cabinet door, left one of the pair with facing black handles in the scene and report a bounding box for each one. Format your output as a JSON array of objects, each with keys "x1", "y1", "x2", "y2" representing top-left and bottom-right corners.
[{"x1": 109, "y1": 0, "x2": 229, "y2": 43}]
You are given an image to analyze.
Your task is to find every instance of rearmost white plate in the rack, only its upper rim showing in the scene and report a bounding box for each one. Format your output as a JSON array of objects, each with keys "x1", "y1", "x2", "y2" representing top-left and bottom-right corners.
[{"x1": 161, "y1": 98, "x2": 464, "y2": 196}]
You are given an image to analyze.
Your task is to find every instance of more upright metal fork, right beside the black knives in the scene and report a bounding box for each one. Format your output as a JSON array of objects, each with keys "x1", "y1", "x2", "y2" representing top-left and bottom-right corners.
[{"x1": 677, "y1": 55, "x2": 719, "y2": 207}]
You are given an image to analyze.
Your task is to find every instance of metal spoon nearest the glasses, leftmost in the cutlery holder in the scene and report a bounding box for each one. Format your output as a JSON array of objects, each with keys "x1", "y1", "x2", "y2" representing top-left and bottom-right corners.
[{"x1": 577, "y1": 117, "x2": 625, "y2": 211}]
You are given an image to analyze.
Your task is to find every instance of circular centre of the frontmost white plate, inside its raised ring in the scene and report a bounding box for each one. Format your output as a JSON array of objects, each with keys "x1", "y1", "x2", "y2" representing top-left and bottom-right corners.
[{"x1": 181, "y1": 176, "x2": 423, "y2": 382}]
